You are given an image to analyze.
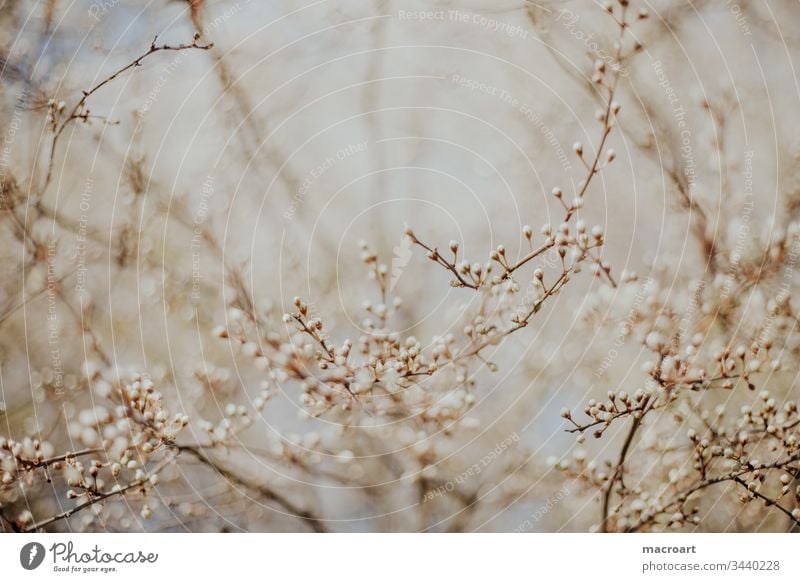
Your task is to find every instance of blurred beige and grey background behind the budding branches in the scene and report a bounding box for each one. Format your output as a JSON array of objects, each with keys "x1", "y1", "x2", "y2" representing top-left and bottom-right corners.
[{"x1": 0, "y1": 0, "x2": 800, "y2": 531}]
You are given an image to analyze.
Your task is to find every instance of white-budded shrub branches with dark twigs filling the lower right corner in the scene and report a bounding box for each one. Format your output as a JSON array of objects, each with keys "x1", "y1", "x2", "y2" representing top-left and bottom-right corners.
[{"x1": 558, "y1": 262, "x2": 800, "y2": 531}]
